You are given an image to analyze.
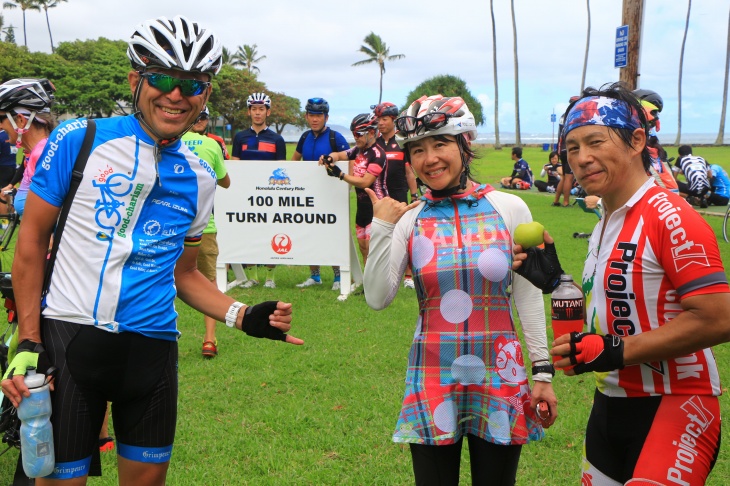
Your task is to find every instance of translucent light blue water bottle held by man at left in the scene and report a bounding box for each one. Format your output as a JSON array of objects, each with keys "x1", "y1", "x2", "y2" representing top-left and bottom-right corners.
[{"x1": 18, "y1": 368, "x2": 56, "y2": 478}]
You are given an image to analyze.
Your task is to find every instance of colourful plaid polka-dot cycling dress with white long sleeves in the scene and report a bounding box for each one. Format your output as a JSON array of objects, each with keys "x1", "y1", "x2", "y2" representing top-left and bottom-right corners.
[{"x1": 365, "y1": 185, "x2": 548, "y2": 445}]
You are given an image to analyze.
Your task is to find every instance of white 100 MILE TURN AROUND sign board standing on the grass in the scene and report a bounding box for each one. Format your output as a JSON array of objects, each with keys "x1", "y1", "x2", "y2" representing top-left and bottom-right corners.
[{"x1": 214, "y1": 160, "x2": 359, "y2": 292}]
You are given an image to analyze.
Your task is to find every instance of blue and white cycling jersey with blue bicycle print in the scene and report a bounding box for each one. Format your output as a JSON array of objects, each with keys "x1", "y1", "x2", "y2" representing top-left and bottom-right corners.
[{"x1": 30, "y1": 115, "x2": 216, "y2": 340}]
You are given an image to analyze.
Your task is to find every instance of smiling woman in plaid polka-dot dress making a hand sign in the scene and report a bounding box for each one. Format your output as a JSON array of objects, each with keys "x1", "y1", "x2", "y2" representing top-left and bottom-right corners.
[{"x1": 364, "y1": 95, "x2": 557, "y2": 485}]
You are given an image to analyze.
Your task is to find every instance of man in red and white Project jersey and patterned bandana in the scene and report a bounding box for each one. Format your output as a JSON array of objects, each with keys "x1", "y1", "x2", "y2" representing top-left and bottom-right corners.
[{"x1": 514, "y1": 84, "x2": 730, "y2": 486}]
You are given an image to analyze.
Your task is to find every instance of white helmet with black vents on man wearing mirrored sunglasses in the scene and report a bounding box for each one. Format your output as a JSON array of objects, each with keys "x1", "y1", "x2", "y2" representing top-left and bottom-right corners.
[{"x1": 127, "y1": 15, "x2": 223, "y2": 75}]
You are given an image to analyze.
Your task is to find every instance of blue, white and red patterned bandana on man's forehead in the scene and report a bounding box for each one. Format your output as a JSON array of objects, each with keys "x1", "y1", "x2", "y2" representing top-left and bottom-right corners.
[{"x1": 563, "y1": 96, "x2": 642, "y2": 136}]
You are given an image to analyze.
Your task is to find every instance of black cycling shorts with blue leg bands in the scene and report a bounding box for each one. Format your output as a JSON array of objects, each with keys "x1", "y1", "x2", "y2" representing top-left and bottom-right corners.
[{"x1": 42, "y1": 319, "x2": 178, "y2": 479}]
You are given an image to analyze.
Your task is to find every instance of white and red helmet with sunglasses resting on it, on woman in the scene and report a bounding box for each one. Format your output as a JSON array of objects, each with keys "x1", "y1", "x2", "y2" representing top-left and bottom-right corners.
[{"x1": 395, "y1": 94, "x2": 477, "y2": 144}]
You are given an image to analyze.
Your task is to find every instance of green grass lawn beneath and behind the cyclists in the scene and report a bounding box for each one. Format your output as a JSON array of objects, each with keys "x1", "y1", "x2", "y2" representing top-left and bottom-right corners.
[{"x1": 0, "y1": 144, "x2": 730, "y2": 486}]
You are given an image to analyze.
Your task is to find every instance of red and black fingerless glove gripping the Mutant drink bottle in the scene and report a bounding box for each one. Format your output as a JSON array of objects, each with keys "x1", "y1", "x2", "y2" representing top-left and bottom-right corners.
[{"x1": 568, "y1": 332, "x2": 624, "y2": 375}]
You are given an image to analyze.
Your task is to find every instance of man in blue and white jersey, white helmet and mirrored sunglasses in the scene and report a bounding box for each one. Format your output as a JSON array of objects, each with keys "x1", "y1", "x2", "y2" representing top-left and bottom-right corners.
[{"x1": 2, "y1": 17, "x2": 303, "y2": 485}]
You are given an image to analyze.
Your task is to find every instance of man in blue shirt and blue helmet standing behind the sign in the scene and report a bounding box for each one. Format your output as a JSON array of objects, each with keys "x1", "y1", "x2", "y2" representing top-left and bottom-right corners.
[{"x1": 292, "y1": 98, "x2": 350, "y2": 290}]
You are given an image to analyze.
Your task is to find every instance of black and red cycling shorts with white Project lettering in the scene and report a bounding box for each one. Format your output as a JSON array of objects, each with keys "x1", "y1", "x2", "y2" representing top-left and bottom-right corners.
[{"x1": 581, "y1": 390, "x2": 721, "y2": 486}]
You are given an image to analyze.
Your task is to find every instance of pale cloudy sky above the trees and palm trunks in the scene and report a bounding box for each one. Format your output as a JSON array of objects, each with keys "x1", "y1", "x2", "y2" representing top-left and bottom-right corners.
[{"x1": 2, "y1": 0, "x2": 730, "y2": 142}]
